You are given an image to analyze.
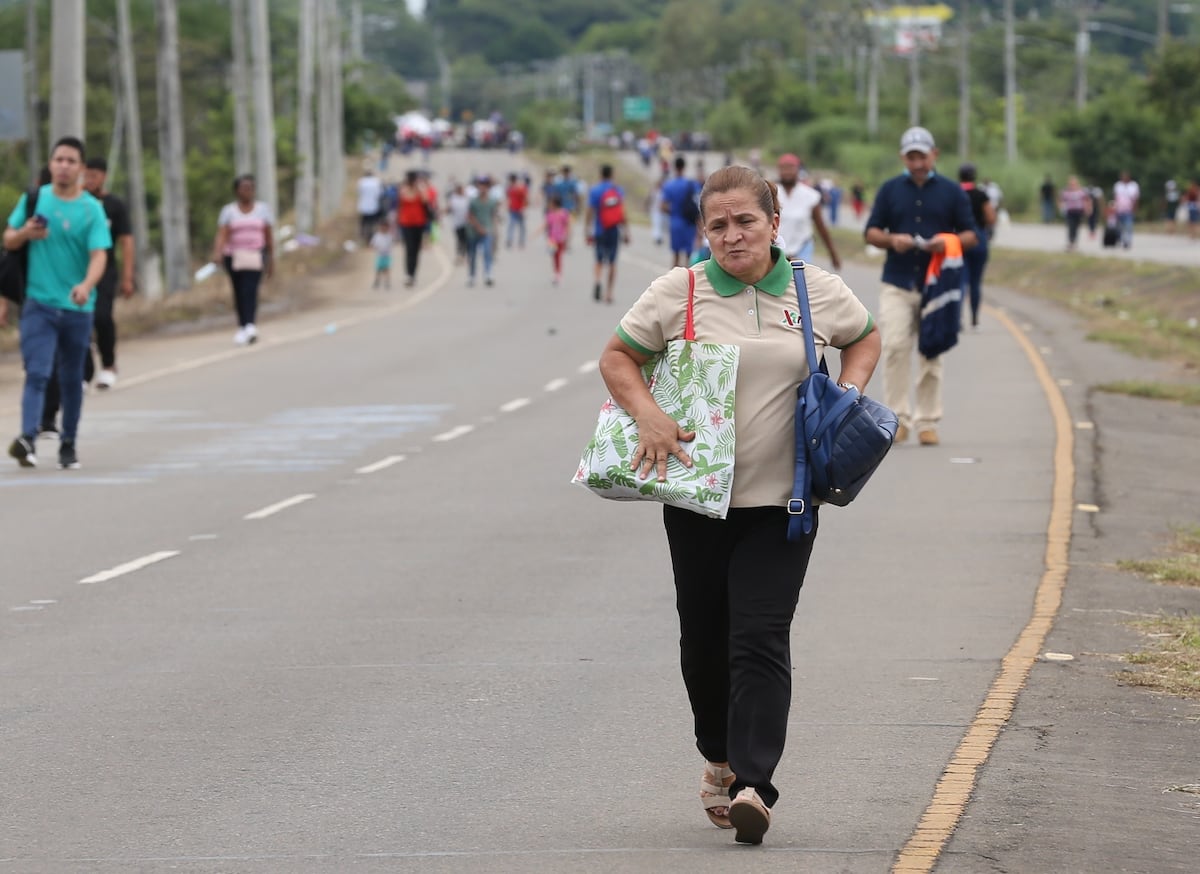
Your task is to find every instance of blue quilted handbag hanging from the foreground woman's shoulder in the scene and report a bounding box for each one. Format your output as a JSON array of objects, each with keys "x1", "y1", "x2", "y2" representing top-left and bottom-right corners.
[{"x1": 787, "y1": 261, "x2": 899, "y2": 540}]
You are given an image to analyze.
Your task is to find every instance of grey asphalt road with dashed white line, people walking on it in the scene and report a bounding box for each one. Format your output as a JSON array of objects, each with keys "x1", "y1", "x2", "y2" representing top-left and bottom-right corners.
[{"x1": 0, "y1": 147, "x2": 1118, "y2": 874}]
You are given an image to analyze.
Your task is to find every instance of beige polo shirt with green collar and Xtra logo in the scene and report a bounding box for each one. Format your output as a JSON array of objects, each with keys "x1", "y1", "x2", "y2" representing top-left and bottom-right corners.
[{"x1": 617, "y1": 247, "x2": 875, "y2": 507}]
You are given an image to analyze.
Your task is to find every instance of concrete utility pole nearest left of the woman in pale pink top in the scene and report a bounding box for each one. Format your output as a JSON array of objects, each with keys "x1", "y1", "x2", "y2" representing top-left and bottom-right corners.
[{"x1": 155, "y1": 0, "x2": 191, "y2": 292}]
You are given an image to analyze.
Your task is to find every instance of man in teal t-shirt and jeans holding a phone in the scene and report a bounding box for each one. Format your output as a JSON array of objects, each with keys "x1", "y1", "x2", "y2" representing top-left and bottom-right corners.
[{"x1": 4, "y1": 137, "x2": 113, "y2": 469}]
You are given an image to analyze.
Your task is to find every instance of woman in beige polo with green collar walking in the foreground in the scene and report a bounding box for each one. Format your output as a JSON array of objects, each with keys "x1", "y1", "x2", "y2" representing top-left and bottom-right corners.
[{"x1": 600, "y1": 167, "x2": 880, "y2": 844}]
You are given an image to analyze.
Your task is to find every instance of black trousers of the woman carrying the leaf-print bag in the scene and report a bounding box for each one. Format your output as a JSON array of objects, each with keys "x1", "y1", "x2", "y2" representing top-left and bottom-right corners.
[{"x1": 662, "y1": 507, "x2": 817, "y2": 807}]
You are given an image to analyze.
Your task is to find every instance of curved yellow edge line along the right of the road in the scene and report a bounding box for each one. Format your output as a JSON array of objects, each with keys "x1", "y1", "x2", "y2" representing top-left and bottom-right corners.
[{"x1": 892, "y1": 306, "x2": 1075, "y2": 874}]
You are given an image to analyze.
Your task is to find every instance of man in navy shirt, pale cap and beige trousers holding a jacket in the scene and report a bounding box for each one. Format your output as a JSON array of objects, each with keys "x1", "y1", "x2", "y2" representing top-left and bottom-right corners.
[{"x1": 865, "y1": 127, "x2": 978, "y2": 447}]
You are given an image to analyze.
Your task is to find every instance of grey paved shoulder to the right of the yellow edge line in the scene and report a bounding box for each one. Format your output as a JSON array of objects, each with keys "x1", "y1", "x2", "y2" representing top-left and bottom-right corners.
[{"x1": 937, "y1": 289, "x2": 1200, "y2": 872}]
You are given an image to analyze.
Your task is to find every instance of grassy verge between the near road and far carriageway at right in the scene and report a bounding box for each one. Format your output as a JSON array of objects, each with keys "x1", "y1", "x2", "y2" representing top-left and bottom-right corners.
[{"x1": 834, "y1": 229, "x2": 1200, "y2": 372}]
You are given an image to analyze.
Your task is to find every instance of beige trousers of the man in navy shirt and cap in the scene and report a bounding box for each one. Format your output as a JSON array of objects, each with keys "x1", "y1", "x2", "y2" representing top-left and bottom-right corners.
[{"x1": 880, "y1": 282, "x2": 942, "y2": 433}]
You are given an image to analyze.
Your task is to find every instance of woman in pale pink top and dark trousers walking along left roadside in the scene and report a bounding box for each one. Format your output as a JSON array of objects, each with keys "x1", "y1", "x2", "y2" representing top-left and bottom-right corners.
[{"x1": 212, "y1": 174, "x2": 275, "y2": 346}]
